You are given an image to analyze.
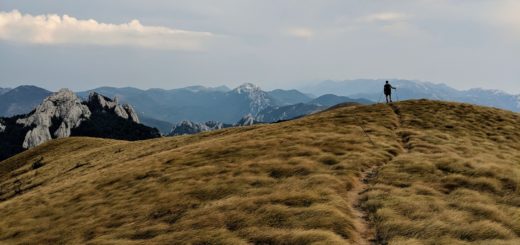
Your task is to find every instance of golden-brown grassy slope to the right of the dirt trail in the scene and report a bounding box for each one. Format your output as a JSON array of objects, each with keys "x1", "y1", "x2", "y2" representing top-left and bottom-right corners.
[{"x1": 364, "y1": 101, "x2": 520, "y2": 244}]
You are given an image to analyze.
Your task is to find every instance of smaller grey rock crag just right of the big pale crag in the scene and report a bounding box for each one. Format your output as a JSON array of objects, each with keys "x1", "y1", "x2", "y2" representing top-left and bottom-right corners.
[{"x1": 87, "y1": 92, "x2": 139, "y2": 123}]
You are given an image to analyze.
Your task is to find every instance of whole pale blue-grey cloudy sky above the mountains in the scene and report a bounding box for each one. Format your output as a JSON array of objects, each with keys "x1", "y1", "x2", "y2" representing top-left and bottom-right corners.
[{"x1": 0, "y1": 0, "x2": 520, "y2": 93}]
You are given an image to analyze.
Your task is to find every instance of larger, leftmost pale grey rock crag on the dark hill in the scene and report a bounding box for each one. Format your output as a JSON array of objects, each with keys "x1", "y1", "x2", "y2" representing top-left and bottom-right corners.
[{"x1": 16, "y1": 89, "x2": 91, "y2": 149}]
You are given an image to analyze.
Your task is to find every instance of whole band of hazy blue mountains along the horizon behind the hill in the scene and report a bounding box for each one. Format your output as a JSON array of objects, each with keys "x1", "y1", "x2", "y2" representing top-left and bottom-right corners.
[{"x1": 4, "y1": 79, "x2": 520, "y2": 135}]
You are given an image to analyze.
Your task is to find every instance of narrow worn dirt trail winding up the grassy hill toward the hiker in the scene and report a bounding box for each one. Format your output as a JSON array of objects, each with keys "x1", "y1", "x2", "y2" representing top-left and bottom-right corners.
[{"x1": 348, "y1": 104, "x2": 411, "y2": 245}]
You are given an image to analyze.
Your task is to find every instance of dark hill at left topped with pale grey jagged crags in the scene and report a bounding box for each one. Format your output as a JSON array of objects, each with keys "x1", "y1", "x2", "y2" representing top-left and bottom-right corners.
[{"x1": 0, "y1": 89, "x2": 160, "y2": 160}]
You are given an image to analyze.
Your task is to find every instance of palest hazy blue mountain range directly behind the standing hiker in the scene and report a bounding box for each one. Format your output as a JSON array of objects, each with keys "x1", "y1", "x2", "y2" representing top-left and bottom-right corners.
[{"x1": 301, "y1": 79, "x2": 520, "y2": 112}]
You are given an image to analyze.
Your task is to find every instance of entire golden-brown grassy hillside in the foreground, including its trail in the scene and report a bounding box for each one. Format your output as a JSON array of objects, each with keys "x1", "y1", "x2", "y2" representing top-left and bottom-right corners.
[{"x1": 0, "y1": 100, "x2": 520, "y2": 244}]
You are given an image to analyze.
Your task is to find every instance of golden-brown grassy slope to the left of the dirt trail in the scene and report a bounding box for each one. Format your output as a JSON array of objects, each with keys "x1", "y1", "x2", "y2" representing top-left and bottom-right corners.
[{"x1": 0, "y1": 103, "x2": 399, "y2": 244}]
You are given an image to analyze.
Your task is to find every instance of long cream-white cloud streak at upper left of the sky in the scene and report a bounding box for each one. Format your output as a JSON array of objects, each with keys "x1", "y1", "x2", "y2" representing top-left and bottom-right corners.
[{"x1": 0, "y1": 10, "x2": 214, "y2": 50}]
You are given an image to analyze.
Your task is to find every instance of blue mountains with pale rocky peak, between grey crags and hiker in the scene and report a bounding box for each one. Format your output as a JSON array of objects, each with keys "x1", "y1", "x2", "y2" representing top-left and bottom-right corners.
[{"x1": 78, "y1": 83, "x2": 320, "y2": 124}]
